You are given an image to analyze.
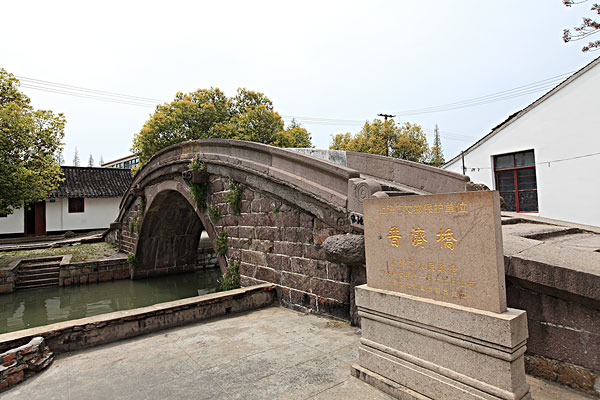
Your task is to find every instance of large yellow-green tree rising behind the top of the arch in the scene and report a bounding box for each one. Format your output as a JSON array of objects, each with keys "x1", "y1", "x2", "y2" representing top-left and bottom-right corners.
[{"x1": 131, "y1": 88, "x2": 311, "y2": 163}]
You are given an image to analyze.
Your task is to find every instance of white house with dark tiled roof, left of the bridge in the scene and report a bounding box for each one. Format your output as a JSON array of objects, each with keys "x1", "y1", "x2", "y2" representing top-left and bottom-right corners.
[{"x1": 0, "y1": 166, "x2": 131, "y2": 236}]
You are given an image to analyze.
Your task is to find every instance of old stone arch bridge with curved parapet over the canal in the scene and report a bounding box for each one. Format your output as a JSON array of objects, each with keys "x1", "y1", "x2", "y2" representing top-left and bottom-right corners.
[{"x1": 110, "y1": 139, "x2": 468, "y2": 319}]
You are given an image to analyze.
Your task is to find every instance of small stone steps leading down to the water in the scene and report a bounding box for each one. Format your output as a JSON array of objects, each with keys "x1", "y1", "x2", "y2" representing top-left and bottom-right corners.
[{"x1": 15, "y1": 256, "x2": 62, "y2": 290}]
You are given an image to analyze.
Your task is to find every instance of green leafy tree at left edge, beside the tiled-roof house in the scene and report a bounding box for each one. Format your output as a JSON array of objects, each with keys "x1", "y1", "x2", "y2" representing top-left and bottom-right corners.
[{"x1": 0, "y1": 68, "x2": 66, "y2": 214}]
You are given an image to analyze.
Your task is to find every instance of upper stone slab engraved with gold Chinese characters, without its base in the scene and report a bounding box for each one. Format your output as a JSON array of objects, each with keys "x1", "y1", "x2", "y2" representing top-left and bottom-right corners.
[{"x1": 363, "y1": 191, "x2": 506, "y2": 313}]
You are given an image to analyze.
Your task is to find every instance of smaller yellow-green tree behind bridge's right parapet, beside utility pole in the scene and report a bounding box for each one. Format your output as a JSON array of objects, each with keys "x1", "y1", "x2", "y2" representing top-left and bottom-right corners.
[{"x1": 329, "y1": 119, "x2": 429, "y2": 162}]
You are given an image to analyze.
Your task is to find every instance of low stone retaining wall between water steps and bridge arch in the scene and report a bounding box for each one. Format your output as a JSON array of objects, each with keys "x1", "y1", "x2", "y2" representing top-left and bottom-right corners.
[{"x1": 58, "y1": 257, "x2": 131, "y2": 286}]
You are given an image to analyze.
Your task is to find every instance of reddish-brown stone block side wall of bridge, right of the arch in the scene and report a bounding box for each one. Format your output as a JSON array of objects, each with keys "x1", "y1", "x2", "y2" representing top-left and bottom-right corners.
[{"x1": 208, "y1": 176, "x2": 352, "y2": 319}]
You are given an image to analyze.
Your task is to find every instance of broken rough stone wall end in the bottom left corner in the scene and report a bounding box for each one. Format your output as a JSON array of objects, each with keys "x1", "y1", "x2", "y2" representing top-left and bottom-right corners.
[{"x1": 0, "y1": 337, "x2": 54, "y2": 392}]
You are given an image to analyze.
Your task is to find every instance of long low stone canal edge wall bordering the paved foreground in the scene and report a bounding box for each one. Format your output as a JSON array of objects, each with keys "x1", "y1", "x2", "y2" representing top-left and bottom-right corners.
[{"x1": 0, "y1": 284, "x2": 276, "y2": 354}]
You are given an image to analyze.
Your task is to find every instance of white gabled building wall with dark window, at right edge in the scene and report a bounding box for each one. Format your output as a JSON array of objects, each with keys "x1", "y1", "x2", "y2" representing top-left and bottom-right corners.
[{"x1": 443, "y1": 57, "x2": 600, "y2": 226}]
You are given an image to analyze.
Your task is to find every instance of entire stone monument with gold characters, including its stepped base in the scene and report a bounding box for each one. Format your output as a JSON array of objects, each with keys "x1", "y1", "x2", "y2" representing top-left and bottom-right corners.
[{"x1": 352, "y1": 191, "x2": 531, "y2": 400}]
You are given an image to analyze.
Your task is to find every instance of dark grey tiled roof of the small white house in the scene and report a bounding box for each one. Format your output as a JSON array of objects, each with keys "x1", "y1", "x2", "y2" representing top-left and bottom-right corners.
[{"x1": 49, "y1": 166, "x2": 132, "y2": 198}]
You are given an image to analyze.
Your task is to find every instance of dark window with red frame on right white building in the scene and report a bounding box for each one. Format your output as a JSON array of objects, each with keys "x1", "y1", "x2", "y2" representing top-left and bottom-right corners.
[{"x1": 494, "y1": 150, "x2": 538, "y2": 212}]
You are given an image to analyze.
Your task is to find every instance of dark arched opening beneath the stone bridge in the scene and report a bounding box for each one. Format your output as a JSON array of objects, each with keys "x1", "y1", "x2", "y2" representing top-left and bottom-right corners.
[{"x1": 132, "y1": 190, "x2": 217, "y2": 278}]
